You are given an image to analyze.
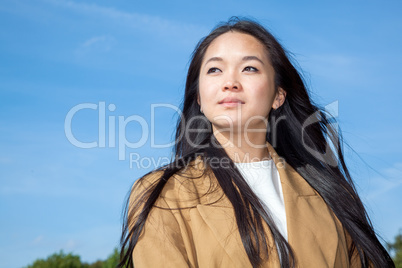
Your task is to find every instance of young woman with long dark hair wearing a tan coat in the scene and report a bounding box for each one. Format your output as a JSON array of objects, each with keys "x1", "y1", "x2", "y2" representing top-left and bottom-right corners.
[{"x1": 120, "y1": 19, "x2": 394, "y2": 267}]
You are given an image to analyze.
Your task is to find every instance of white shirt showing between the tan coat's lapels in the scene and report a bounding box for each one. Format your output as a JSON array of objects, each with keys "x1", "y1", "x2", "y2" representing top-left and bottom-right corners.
[{"x1": 235, "y1": 160, "x2": 288, "y2": 240}]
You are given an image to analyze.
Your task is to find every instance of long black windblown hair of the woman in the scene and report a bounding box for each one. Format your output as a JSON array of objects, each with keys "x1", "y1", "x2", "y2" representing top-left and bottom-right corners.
[{"x1": 119, "y1": 18, "x2": 394, "y2": 267}]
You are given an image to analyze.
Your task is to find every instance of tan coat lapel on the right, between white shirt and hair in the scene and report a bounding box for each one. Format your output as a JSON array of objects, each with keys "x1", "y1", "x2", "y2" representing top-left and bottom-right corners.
[{"x1": 267, "y1": 144, "x2": 347, "y2": 267}]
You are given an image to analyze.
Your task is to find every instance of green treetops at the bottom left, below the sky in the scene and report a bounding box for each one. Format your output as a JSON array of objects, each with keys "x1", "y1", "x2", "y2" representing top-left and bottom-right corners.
[{"x1": 26, "y1": 248, "x2": 120, "y2": 268}]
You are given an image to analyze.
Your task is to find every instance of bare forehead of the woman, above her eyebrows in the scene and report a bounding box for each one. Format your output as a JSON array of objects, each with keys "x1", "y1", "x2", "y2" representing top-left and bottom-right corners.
[{"x1": 204, "y1": 32, "x2": 269, "y2": 60}]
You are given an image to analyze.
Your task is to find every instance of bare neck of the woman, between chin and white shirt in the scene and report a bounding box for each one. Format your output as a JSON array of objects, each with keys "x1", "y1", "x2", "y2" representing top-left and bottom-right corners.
[{"x1": 214, "y1": 126, "x2": 271, "y2": 163}]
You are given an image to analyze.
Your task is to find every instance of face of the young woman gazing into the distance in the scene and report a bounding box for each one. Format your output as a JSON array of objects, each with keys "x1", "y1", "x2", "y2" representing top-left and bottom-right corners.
[{"x1": 198, "y1": 32, "x2": 277, "y2": 131}]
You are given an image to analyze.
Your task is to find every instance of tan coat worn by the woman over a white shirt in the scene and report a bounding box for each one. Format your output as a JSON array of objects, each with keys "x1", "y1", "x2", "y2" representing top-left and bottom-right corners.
[{"x1": 132, "y1": 144, "x2": 360, "y2": 268}]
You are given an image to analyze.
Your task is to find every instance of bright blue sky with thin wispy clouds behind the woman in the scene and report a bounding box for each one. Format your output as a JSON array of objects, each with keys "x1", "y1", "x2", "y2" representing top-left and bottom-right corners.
[{"x1": 0, "y1": 0, "x2": 402, "y2": 267}]
